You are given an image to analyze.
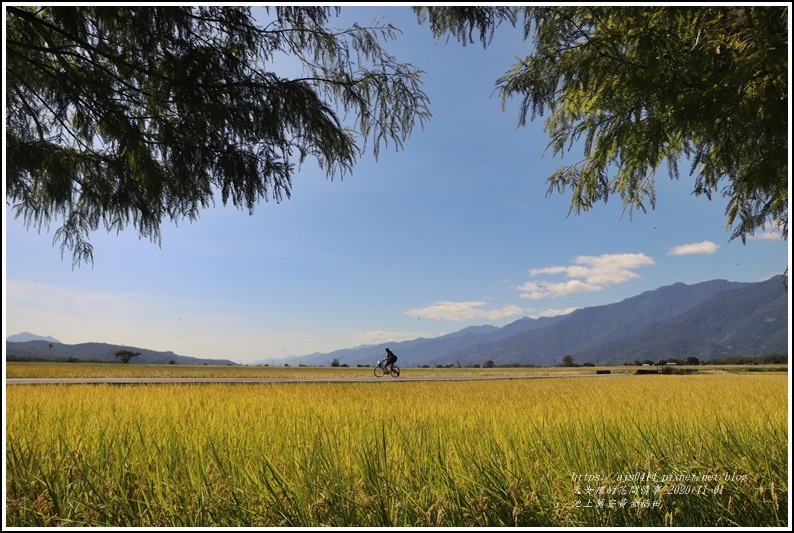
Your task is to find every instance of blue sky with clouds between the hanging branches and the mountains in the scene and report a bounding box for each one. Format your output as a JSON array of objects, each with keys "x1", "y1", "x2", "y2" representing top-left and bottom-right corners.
[{"x1": 3, "y1": 6, "x2": 791, "y2": 363}]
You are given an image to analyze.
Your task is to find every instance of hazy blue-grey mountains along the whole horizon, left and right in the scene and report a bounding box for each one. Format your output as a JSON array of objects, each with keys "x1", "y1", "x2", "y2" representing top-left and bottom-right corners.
[{"x1": 6, "y1": 276, "x2": 790, "y2": 367}]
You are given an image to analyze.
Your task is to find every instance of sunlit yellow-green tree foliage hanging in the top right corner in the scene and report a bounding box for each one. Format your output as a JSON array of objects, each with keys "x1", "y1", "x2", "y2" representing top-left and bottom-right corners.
[{"x1": 414, "y1": 6, "x2": 789, "y2": 241}]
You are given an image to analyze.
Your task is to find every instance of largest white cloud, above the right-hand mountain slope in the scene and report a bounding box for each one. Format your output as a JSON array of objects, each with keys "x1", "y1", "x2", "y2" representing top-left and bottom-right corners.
[{"x1": 518, "y1": 254, "x2": 656, "y2": 300}]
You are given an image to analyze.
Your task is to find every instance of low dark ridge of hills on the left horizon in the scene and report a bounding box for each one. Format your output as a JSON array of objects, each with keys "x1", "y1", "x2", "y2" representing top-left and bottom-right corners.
[{"x1": 5, "y1": 340, "x2": 238, "y2": 365}]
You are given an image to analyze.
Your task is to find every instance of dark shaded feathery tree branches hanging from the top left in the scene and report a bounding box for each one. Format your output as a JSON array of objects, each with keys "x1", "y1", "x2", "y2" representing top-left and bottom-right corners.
[{"x1": 5, "y1": 6, "x2": 430, "y2": 265}]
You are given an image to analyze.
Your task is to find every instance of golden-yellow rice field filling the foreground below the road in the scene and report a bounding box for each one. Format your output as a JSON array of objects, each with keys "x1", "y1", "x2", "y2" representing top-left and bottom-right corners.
[{"x1": 6, "y1": 365, "x2": 789, "y2": 527}]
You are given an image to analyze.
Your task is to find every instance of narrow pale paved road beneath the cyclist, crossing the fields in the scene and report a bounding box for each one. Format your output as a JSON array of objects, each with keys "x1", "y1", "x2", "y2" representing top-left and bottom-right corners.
[{"x1": 6, "y1": 374, "x2": 621, "y2": 385}]
